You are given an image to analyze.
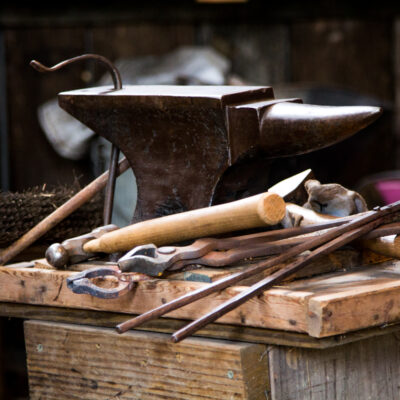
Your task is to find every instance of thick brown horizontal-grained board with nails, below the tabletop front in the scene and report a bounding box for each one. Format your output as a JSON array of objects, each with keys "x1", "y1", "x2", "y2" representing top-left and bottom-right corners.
[{"x1": 25, "y1": 321, "x2": 269, "y2": 400}]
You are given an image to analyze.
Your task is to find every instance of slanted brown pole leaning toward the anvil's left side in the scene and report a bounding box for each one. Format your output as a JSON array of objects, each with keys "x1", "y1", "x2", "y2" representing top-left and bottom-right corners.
[{"x1": 0, "y1": 158, "x2": 129, "y2": 265}]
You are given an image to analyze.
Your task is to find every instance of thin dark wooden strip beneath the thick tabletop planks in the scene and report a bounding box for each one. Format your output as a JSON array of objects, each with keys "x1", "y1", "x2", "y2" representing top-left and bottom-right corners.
[{"x1": 0, "y1": 303, "x2": 400, "y2": 349}]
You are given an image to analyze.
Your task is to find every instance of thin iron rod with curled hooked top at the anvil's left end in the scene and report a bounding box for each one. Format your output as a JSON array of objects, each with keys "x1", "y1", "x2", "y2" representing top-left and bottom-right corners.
[{"x1": 29, "y1": 54, "x2": 122, "y2": 225}]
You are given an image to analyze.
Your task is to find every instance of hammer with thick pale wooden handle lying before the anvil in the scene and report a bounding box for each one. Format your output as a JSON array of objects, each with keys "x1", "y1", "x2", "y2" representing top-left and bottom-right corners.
[{"x1": 46, "y1": 170, "x2": 312, "y2": 268}]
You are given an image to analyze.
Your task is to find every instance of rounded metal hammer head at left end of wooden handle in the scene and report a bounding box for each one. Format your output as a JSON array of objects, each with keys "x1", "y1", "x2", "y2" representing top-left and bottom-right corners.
[{"x1": 45, "y1": 224, "x2": 119, "y2": 268}]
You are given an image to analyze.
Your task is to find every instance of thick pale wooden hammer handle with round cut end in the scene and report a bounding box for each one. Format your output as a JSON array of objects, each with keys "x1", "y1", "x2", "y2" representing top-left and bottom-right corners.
[{"x1": 83, "y1": 193, "x2": 285, "y2": 253}]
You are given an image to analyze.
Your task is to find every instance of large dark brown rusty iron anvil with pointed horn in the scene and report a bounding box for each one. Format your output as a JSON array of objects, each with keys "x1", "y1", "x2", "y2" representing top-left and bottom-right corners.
[{"x1": 58, "y1": 86, "x2": 381, "y2": 222}]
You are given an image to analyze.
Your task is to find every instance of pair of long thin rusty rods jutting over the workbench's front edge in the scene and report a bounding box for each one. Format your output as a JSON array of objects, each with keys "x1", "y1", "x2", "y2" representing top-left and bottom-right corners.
[{"x1": 116, "y1": 201, "x2": 400, "y2": 342}]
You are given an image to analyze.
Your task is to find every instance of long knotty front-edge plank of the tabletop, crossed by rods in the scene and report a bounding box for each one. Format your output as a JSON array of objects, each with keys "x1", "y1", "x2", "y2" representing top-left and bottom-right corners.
[{"x1": 0, "y1": 267, "x2": 308, "y2": 332}]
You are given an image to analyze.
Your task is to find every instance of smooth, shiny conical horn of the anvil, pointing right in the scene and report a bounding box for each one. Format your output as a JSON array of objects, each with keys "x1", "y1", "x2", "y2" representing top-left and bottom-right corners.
[{"x1": 261, "y1": 102, "x2": 382, "y2": 157}]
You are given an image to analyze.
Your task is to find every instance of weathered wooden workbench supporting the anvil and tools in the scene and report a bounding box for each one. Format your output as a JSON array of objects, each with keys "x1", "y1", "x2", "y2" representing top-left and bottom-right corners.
[{"x1": 0, "y1": 253, "x2": 400, "y2": 400}]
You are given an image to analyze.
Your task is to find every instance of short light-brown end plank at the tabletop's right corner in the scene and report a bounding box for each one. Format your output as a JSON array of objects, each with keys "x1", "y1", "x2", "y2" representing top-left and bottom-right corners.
[{"x1": 308, "y1": 262, "x2": 400, "y2": 337}]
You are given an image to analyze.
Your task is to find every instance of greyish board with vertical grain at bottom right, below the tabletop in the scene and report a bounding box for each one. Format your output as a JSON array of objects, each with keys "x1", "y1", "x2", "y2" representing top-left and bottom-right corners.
[{"x1": 268, "y1": 333, "x2": 400, "y2": 400}]
